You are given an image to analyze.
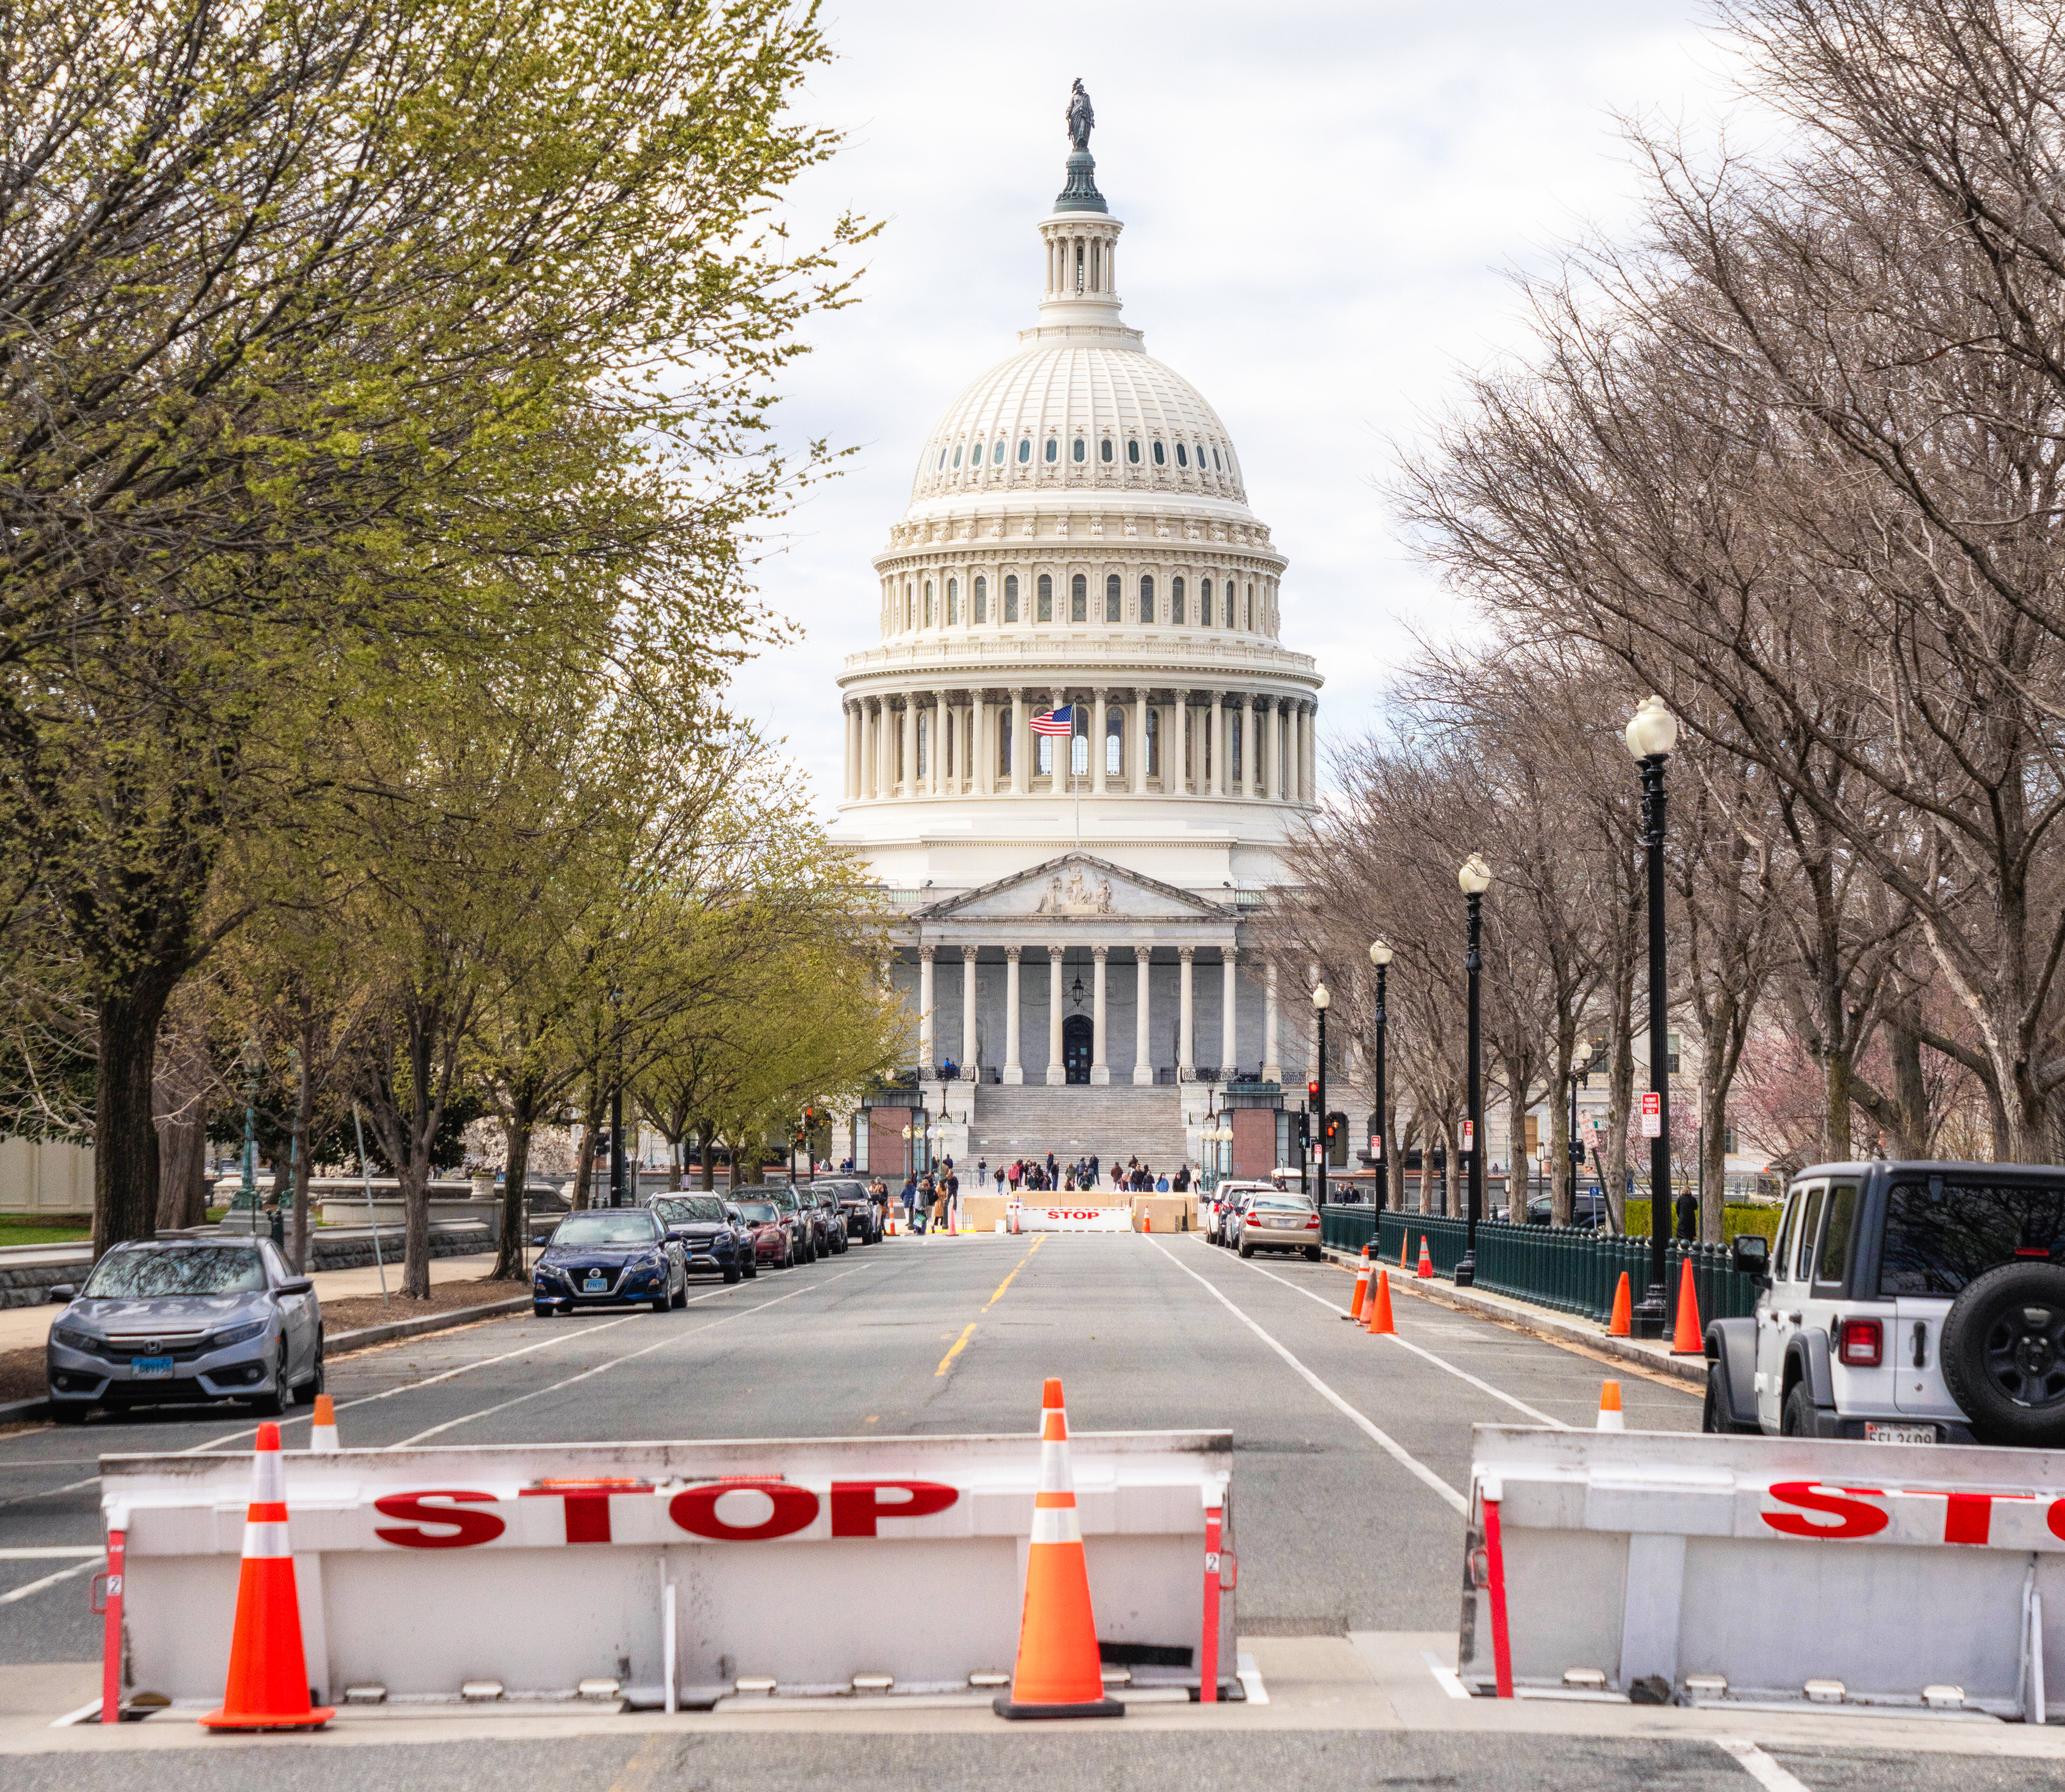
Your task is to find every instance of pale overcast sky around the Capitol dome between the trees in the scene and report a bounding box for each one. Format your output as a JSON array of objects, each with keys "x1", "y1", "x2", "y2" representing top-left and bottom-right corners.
[{"x1": 735, "y1": 0, "x2": 1724, "y2": 820}]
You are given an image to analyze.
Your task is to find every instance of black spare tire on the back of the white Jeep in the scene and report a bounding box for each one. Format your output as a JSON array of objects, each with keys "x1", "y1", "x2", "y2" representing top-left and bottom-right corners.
[{"x1": 1943, "y1": 1261, "x2": 2065, "y2": 1447}]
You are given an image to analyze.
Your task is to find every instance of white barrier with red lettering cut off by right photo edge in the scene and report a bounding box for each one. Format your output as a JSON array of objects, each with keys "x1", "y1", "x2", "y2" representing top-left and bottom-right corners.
[{"x1": 1460, "y1": 1424, "x2": 2065, "y2": 1722}]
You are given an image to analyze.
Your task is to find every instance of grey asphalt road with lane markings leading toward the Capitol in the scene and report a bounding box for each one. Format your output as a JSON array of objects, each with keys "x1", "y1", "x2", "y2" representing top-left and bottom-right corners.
[{"x1": 0, "y1": 1234, "x2": 2055, "y2": 1792}]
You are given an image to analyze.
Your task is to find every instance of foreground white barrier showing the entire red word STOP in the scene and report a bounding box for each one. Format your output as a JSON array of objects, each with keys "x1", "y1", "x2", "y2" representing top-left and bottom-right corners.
[{"x1": 101, "y1": 1431, "x2": 1235, "y2": 1710}]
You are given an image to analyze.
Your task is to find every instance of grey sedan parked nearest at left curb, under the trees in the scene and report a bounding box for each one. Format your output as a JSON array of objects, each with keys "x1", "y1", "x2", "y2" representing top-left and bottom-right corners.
[{"x1": 46, "y1": 1239, "x2": 322, "y2": 1424}]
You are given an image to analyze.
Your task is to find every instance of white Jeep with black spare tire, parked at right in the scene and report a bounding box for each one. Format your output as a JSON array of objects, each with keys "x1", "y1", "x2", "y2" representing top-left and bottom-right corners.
[{"x1": 1704, "y1": 1162, "x2": 2065, "y2": 1449}]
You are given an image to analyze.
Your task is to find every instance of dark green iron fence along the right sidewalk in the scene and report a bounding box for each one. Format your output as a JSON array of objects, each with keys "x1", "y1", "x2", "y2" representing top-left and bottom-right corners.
[{"x1": 1319, "y1": 1206, "x2": 1757, "y2": 1336}]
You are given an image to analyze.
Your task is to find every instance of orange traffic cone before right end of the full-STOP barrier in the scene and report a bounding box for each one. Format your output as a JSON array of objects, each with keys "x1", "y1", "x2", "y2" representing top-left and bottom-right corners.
[{"x1": 995, "y1": 1377, "x2": 1125, "y2": 1718}]
